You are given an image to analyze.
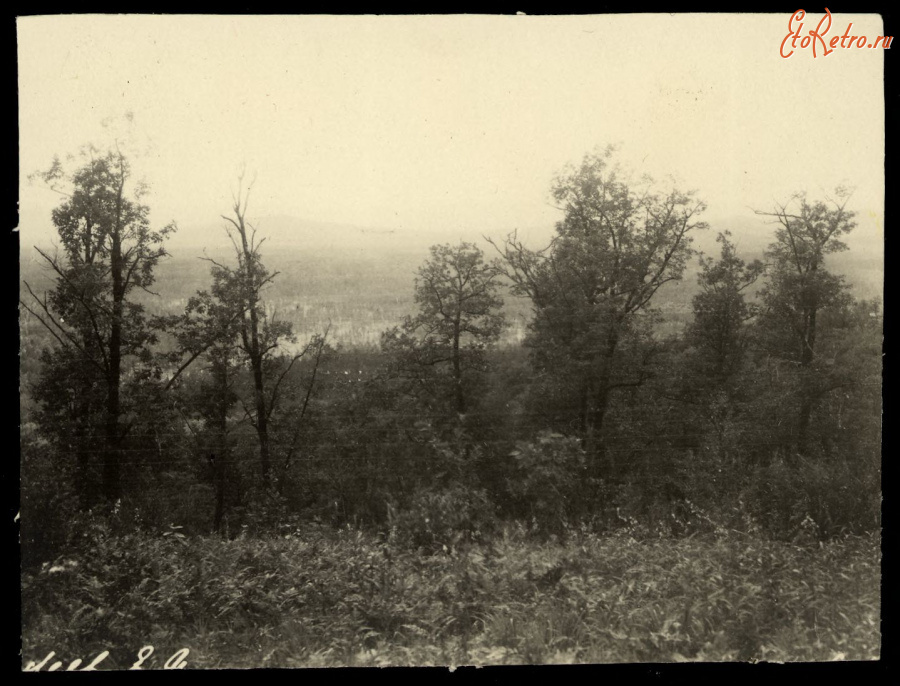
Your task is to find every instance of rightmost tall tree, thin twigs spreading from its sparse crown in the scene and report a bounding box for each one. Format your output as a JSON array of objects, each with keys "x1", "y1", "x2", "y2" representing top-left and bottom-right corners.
[{"x1": 757, "y1": 188, "x2": 856, "y2": 453}]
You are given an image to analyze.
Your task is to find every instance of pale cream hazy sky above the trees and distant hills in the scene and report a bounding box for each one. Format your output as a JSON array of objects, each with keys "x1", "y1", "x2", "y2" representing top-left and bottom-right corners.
[{"x1": 18, "y1": 13, "x2": 884, "y2": 255}]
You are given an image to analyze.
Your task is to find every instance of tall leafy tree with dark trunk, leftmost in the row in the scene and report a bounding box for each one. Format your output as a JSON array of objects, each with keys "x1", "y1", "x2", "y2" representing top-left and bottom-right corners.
[{"x1": 22, "y1": 147, "x2": 175, "y2": 501}]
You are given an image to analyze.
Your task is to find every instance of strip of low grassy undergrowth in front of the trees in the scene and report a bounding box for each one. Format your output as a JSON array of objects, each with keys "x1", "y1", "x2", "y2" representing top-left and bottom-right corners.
[{"x1": 22, "y1": 529, "x2": 881, "y2": 669}]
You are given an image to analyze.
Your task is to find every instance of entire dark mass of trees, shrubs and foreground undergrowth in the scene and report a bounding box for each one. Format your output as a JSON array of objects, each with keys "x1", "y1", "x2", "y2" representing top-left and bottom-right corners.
[{"x1": 20, "y1": 148, "x2": 883, "y2": 667}]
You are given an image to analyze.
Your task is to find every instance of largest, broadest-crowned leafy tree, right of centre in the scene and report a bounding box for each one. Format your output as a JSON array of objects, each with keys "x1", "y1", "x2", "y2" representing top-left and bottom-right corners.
[{"x1": 498, "y1": 148, "x2": 706, "y2": 474}]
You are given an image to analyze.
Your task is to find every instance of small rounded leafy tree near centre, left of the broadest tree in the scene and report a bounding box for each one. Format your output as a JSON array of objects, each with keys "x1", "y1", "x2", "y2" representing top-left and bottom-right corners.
[{"x1": 382, "y1": 243, "x2": 504, "y2": 422}]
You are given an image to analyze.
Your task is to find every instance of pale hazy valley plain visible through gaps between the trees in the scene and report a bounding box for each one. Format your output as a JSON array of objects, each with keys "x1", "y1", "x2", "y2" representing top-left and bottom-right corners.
[{"x1": 21, "y1": 242, "x2": 884, "y2": 348}]
